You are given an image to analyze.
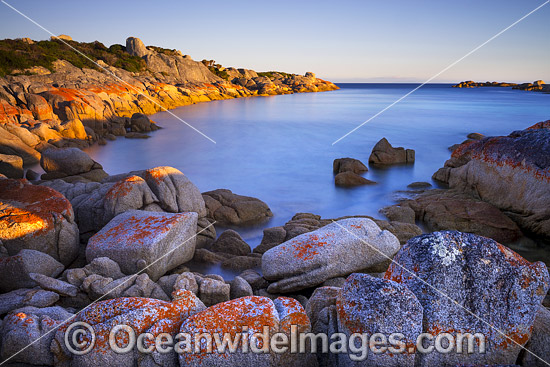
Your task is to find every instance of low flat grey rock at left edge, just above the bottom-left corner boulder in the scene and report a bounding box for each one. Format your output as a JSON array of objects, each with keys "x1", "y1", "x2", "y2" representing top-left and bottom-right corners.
[{"x1": 0, "y1": 288, "x2": 59, "y2": 315}]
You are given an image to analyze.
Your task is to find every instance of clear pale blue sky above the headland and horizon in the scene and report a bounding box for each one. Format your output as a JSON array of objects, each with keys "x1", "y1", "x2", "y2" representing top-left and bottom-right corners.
[{"x1": 0, "y1": 0, "x2": 550, "y2": 82}]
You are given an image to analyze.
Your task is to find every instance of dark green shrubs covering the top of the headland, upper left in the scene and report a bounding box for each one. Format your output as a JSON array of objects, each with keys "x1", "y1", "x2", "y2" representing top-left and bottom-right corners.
[{"x1": 0, "y1": 39, "x2": 146, "y2": 76}]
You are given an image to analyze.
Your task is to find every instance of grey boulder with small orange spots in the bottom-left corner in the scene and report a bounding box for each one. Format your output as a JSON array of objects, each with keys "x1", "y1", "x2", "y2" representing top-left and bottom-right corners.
[{"x1": 0, "y1": 306, "x2": 74, "y2": 366}]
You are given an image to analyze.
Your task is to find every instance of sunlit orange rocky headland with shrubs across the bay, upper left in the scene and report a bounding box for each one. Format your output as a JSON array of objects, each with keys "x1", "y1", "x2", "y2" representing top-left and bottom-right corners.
[{"x1": 0, "y1": 37, "x2": 339, "y2": 169}]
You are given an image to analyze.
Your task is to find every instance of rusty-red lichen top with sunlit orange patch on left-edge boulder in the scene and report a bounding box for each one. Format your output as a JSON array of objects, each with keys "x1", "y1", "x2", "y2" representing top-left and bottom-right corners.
[{"x1": 0, "y1": 180, "x2": 73, "y2": 240}]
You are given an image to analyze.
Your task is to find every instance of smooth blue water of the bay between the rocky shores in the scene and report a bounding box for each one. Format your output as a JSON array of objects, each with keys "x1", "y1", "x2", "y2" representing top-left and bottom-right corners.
[{"x1": 88, "y1": 84, "x2": 550, "y2": 258}]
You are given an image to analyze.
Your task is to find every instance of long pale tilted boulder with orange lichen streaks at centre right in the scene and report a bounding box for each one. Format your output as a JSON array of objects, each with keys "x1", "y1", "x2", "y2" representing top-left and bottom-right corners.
[{"x1": 262, "y1": 218, "x2": 400, "y2": 293}]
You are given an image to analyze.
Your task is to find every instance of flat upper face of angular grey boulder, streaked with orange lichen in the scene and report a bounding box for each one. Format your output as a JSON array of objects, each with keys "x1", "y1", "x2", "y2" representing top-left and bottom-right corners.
[{"x1": 88, "y1": 213, "x2": 189, "y2": 248}]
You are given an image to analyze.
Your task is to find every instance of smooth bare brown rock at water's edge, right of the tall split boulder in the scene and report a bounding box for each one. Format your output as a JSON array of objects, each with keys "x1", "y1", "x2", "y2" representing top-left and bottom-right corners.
[{"x1": 203, "y1": 189, "x2": 273, "y2": 225}]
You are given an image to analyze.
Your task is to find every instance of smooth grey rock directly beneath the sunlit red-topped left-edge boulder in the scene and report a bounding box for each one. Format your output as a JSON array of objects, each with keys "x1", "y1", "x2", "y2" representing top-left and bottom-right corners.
[{"x1": 0, "y1": 249, "x2": 64, "y2": 292}]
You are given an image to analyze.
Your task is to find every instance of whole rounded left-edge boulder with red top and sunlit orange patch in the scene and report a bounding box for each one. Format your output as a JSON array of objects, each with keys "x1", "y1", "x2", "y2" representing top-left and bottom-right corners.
[{"x1": 0, "y1": 180, "x2": 79, "y2": 265}]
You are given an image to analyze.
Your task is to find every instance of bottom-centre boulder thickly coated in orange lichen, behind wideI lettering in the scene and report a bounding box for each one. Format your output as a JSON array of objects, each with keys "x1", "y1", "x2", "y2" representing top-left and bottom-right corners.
[{"x1": 179, "y1": 296, "x2": 312, "y2": 367}]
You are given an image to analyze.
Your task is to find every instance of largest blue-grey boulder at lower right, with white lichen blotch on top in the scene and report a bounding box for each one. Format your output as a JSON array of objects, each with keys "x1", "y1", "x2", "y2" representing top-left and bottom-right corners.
[{"x1": 385, "y1": 231, "x2": 550, "y2": 366}]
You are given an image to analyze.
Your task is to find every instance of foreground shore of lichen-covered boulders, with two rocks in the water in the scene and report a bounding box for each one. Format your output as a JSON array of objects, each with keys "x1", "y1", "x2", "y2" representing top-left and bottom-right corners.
[{"x1": 0, "y1": 116, "x2": 550, "y2": 366}]
